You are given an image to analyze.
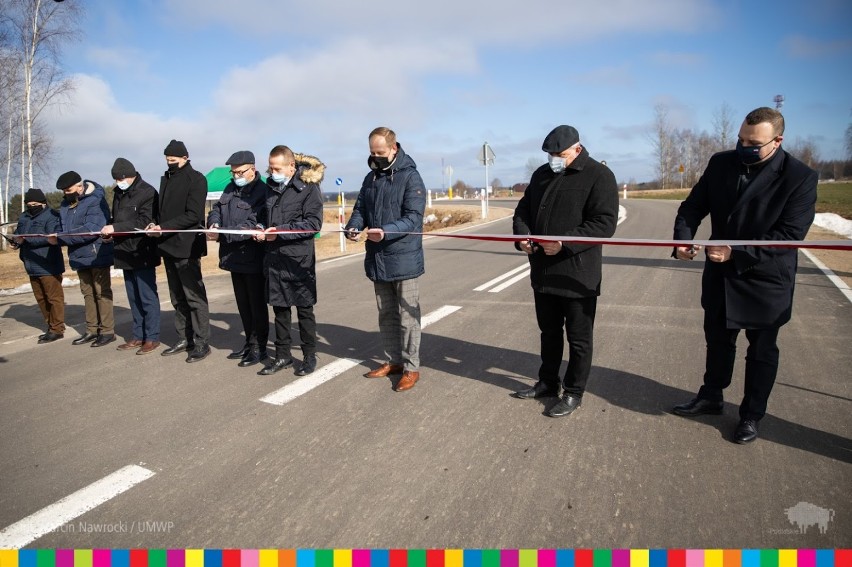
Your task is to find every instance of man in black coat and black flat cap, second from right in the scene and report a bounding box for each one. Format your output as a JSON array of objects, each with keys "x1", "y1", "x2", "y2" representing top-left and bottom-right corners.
[{"x1": 513, "y1": 125, "x2": 618, "y2": 417}]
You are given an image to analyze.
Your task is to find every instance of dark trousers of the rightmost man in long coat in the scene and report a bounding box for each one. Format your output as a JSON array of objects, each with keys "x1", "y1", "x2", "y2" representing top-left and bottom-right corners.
[{"x1": 698, "y1": 309, "x2": 779, "y2": 420}]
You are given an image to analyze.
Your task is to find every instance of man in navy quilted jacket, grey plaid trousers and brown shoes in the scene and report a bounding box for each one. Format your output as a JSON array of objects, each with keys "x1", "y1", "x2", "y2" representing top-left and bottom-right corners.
[{"x1": 346, "y1": 127, "x2": 426, "y2": 392}]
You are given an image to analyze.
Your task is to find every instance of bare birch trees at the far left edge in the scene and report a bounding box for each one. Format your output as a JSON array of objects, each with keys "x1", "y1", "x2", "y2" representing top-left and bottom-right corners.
[{"x1": 0, "y1": 0, "x2": 81, "y2": 244}]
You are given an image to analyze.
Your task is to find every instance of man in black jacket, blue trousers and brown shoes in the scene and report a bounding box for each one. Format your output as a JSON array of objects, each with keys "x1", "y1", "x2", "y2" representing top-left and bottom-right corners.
[{"x1": 101, "y1": 157, "x2": 160, "y2": 354}]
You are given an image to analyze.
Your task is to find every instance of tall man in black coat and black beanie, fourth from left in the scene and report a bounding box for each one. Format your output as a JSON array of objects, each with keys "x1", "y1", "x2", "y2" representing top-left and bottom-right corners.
[{"x1": 148, "y1": 140, "x2": 210, "y2": 362}]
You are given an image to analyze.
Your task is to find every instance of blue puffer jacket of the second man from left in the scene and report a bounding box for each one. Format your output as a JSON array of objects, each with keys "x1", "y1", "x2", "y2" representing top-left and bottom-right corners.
[{"x1": 57, "y1": 179, "x2": 112, "y2": 271}]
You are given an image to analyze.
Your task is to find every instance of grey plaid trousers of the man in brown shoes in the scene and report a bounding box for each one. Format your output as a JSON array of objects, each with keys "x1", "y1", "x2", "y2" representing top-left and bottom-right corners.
[{"x1": 373, "y1": 278, "x2": 420, "y2": 371}]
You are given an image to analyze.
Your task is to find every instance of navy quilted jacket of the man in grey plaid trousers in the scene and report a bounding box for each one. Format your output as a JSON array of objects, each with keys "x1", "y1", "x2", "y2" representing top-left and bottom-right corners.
[{"x1": 346, "y1": 144, "x2": 426, "y2": 282}]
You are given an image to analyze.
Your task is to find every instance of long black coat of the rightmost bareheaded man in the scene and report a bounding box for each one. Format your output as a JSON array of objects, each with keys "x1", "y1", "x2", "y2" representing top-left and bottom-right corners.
[{"x1": 674, "y1": 149, "x2": 818, "y2": 329}]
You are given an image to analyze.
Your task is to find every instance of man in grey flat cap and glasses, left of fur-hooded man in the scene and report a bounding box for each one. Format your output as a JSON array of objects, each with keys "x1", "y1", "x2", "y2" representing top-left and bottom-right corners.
[{"x1": 207, "y1": 150, "x2": 269, "y2": 367}]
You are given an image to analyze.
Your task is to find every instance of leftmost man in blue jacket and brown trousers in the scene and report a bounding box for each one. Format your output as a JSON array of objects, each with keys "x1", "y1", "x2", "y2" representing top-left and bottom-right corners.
[{"x1": 12, "y1": 189, "x2": 65, "y2": 344}]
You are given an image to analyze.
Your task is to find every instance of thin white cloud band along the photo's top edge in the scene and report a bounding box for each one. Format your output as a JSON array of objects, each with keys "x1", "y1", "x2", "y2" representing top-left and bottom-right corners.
[{"x1": 162, "y1": 0, "x2": 718, "y2": 45}]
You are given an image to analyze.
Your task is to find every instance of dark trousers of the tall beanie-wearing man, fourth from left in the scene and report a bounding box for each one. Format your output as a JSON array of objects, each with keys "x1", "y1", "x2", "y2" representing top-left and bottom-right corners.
[{"x1": 163, "y1": 256, "x2": 210, "y2": 344}]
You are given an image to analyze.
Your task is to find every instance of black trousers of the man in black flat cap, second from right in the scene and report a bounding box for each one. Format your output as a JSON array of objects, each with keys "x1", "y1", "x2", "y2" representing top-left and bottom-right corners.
[{"x1": 535, "y1": 292, "x2": 598, "y2": 397}]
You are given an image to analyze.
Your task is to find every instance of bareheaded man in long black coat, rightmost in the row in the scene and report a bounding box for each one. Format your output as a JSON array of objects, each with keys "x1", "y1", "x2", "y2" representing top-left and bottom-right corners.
[{"x1": 673, "y1": 107, "x2": 817, "y2": 443}]
